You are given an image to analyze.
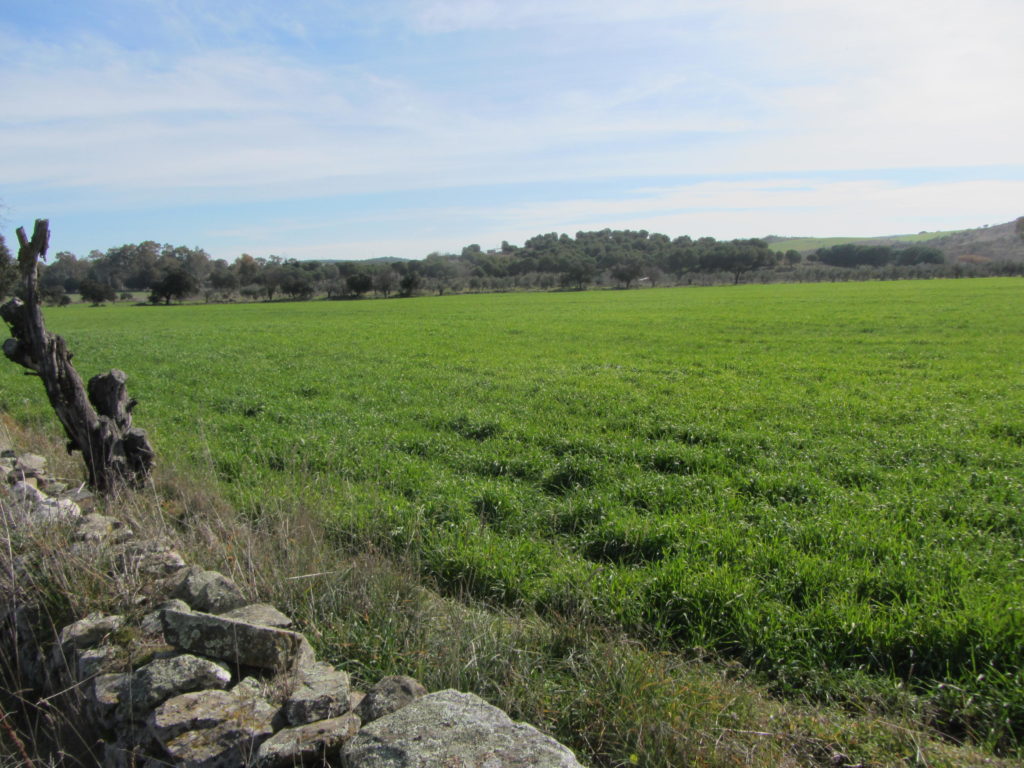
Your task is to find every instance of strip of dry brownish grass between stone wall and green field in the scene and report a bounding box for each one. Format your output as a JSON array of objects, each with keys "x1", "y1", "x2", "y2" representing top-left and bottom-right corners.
[{"x1": 0, "y1": 421, "x2": 1011, "y2": 768}]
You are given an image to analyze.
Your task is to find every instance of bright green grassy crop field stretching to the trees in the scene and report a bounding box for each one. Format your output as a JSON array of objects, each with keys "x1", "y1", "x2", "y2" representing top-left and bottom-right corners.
[{"x1": 0, "y1": 279, "x2": 1024, "y2": 750}]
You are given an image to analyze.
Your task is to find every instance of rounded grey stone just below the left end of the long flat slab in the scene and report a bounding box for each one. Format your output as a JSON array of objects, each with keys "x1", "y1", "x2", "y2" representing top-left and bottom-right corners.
[{"x1": 120, "y1": 653, "x2": 231, "y2": 720}]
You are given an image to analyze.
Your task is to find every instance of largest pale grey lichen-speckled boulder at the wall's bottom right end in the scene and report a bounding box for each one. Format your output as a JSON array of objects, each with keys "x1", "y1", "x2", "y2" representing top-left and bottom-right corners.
[{"x1": 343, "y1": 690, "x2": 581, "y2": 768}]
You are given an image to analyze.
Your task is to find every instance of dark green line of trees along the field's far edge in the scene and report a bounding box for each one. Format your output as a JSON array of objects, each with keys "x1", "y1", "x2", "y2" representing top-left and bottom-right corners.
[{"x1": 0, "y1": 229, "x2": 1022, "y2": 304}]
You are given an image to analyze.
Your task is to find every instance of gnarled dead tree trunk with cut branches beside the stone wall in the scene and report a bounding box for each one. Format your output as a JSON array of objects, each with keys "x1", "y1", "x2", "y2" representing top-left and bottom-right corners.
[{"x1": 0, "y1": 219, "x2": 154, "y2": 494}]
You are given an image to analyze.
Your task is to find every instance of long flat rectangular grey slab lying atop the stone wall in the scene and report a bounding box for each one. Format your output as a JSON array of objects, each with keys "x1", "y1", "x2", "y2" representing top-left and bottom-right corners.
[{"x1": 162, "y1": 610, "x2": 308, "y2": 671}]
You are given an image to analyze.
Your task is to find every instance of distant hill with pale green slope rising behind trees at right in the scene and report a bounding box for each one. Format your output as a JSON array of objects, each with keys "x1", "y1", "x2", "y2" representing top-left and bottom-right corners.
[{"x1": 764, "y1": 217, "x2": 1024, "y2": 261}]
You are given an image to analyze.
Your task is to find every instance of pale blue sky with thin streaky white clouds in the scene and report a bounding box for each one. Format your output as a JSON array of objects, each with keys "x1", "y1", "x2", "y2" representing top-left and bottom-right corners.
[{"x1": 0, "y1": 0, "x2": 1024, "y2": 261}]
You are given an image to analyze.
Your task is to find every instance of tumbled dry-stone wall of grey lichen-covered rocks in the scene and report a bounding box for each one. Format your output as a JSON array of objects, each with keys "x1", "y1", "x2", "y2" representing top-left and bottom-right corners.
[{"x1": 0, "y1": 451, "x2": 579, "y2": 768}]
